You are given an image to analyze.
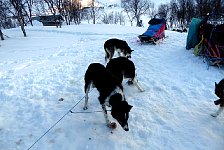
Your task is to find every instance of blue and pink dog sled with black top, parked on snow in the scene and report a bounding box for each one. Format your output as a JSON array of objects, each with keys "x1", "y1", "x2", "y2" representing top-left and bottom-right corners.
[{"x1": 138, "y1": 17, "x2": 166, "y2": 44}]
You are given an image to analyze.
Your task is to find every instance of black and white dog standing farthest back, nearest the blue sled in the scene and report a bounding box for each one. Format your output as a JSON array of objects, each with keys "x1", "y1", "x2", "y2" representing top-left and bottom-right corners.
[{"x1": 104, "y1": 38, "x2": 134, "y2": 62}]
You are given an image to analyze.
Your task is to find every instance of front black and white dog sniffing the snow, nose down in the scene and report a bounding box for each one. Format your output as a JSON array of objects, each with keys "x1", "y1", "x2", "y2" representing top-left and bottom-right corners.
[{"x1": 83, "y1": 63, "x2": 132, "y2": 131}]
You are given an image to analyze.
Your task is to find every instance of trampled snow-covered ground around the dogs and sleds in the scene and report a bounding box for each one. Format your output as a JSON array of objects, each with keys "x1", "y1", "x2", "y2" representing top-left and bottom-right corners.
[{"x1": 0, "y1": 24, "x2": 224, "y2": 150}]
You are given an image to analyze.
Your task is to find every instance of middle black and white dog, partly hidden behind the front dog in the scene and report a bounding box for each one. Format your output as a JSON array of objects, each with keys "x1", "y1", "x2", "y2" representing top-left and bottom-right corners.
[{"x1": 106, "y1": 57, "x2": 144, "y2": 92}]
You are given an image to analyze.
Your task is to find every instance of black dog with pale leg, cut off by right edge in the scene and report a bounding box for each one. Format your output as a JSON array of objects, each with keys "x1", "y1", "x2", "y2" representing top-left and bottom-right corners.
[{"x1": 211, "y1": 79, "x2": 224, "y2": 117}]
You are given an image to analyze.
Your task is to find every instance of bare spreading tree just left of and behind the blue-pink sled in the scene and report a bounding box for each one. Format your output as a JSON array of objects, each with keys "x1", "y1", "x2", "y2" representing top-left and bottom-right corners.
[{"x1": 122, "y1": 0, "x2": 151, "y2": 26}]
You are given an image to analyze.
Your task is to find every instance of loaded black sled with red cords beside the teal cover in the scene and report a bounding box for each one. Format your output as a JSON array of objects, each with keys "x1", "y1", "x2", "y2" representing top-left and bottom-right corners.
[{"x1": 186, "y1": 14, "x2": 224, "y2": 68}]
